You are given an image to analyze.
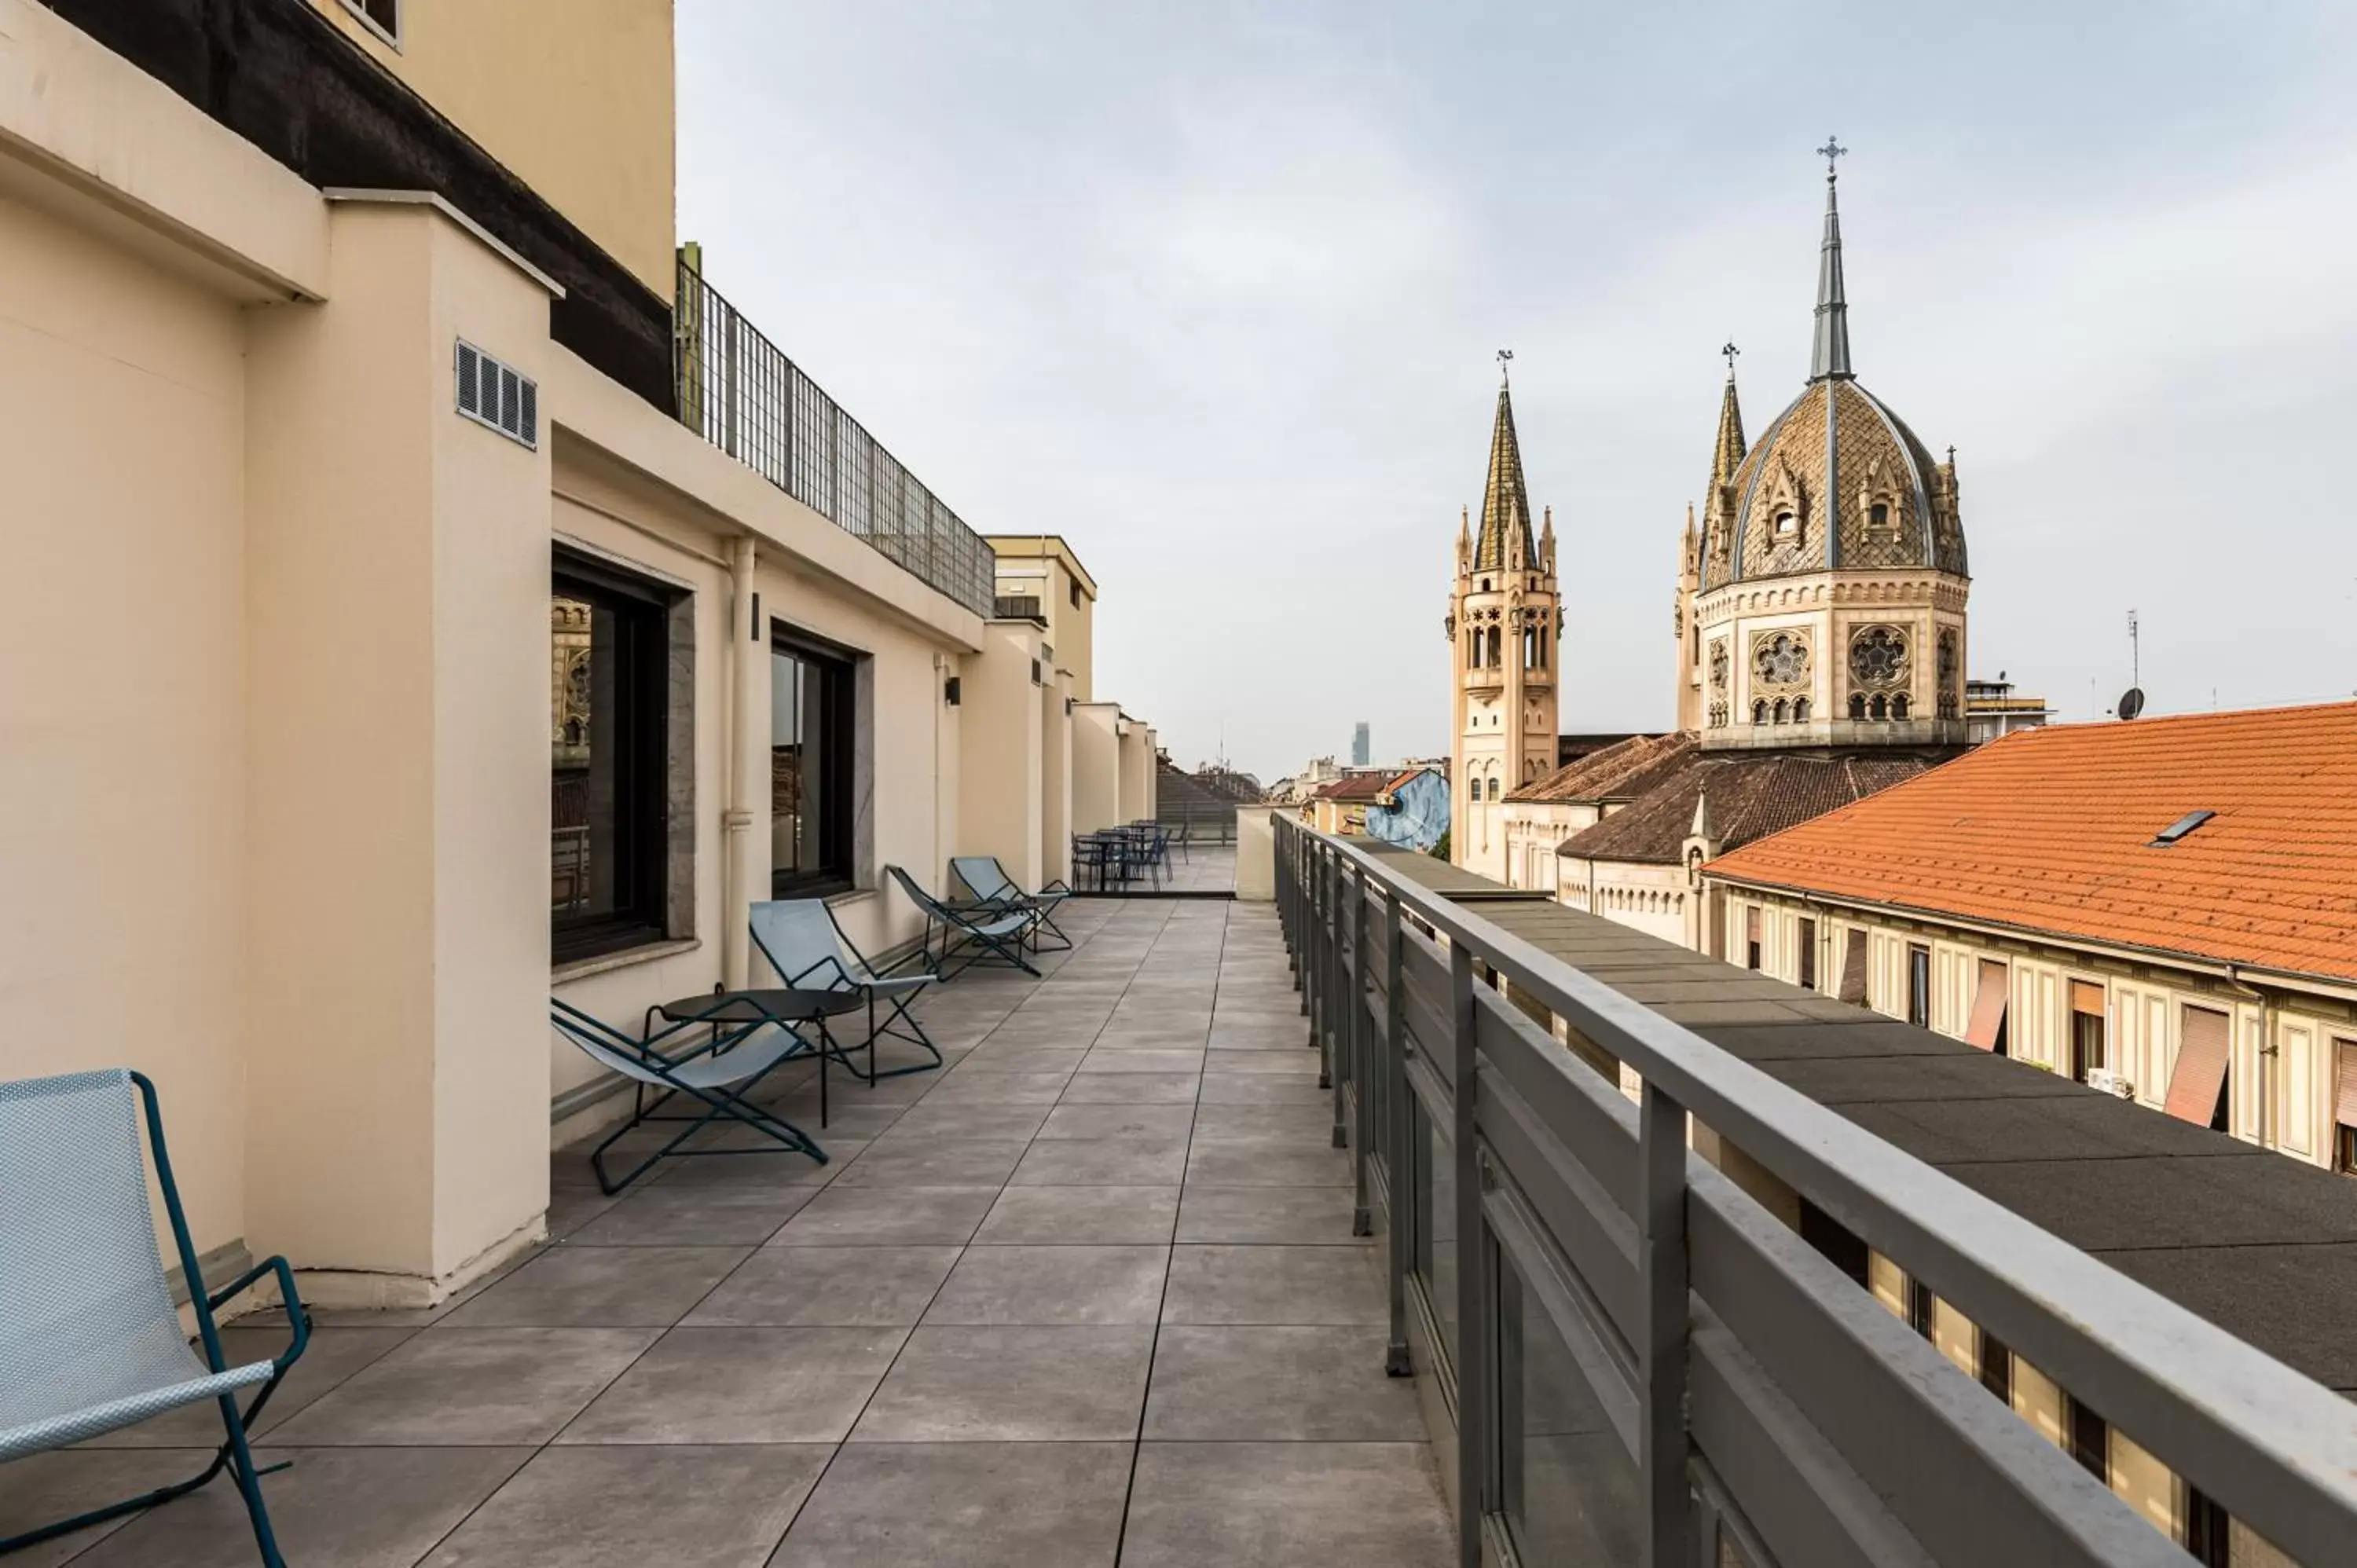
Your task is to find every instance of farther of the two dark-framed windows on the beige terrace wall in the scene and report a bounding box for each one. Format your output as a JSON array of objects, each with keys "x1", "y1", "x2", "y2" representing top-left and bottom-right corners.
[{"x1": 768, "y1": 627, "x2": 856, "y2": 899}]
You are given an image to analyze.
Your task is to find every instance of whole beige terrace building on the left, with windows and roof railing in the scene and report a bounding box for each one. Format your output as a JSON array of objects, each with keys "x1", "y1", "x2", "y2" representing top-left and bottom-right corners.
[{"x1": 0, "y1": 0, "x2": 1155, "y2": 1306}]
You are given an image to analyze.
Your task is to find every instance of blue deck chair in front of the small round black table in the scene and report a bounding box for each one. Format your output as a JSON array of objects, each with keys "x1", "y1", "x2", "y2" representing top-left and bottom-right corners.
[{"x1": 549, "y1": 993, "x2": 827, "y2": 1196}]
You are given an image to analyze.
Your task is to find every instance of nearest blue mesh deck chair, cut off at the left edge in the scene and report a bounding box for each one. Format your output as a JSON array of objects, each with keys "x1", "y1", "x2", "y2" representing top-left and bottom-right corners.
[{"x1": 0, "y1": 1068, "x2": 311, "y2": 1568}]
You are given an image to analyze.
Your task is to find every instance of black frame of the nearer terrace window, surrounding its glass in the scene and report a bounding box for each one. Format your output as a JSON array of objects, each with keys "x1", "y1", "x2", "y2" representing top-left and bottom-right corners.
[{"x1": 549, "y1": 547, "x2": 681, "y2": 965}]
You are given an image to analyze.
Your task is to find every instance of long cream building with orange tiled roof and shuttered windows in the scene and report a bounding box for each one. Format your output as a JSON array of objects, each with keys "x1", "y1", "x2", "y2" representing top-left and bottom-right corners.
[{"x1": 1702, "y1": 702, "x2": 2357, "y2": 1172}]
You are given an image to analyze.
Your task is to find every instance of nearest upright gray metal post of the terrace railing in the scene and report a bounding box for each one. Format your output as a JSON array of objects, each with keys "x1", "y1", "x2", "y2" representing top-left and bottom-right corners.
[{"x1": 1638, "y1": 1080, "x2": 1692, "y2": 1568}]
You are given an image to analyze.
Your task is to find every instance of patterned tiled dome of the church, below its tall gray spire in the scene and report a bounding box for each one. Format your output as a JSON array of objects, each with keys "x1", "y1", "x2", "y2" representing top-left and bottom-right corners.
[{"x1": 1702, "y1": 375, "x2": 1970, "y2": 587}]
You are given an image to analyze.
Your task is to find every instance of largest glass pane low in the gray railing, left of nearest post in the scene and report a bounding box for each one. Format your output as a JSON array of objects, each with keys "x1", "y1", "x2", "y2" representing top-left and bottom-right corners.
[{"x1": 1499, "y1": 1255, "x2": 1640, "y2": 1563}]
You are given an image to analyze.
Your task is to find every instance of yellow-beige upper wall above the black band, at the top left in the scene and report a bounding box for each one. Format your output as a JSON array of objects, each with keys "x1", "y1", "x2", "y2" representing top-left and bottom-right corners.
[{"x1": 311, "y1": 0, "x2": 676, "y2": 299}]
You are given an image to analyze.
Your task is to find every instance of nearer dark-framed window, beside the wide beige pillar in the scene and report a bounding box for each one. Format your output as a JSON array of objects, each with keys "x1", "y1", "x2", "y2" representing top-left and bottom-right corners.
[{"x1": 549, "y1": 554, "x2": 672, "y2": 962}]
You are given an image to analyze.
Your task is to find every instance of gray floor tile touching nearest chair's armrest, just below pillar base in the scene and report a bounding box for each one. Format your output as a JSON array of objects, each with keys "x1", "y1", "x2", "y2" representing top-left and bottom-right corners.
[{"x1": 264, "y1": 1328, "x2": 658, "y2": 1448}]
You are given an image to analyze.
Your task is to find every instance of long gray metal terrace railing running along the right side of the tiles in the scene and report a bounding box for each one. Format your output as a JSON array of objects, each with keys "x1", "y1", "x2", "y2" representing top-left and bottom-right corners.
[{"x1": 1275, "y1": 816, "x2": 2357, "y2": 1568}]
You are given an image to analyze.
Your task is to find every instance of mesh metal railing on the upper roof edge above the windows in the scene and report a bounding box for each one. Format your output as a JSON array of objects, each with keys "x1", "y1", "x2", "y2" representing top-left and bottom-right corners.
[{"x1": 672, "y1": 257, "x2": 997, "y2": 615}]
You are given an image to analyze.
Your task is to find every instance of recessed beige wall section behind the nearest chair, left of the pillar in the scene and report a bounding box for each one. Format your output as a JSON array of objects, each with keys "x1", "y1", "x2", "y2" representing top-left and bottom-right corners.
[{"x1": 0, "y1": 186, "x2": 250, "y2": 1252}]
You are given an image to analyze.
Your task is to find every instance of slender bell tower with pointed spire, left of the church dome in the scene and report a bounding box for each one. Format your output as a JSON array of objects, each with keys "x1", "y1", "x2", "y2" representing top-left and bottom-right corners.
[{"x1": 1447, "y1": 349, "x2": 1563, "y2": 882}]
